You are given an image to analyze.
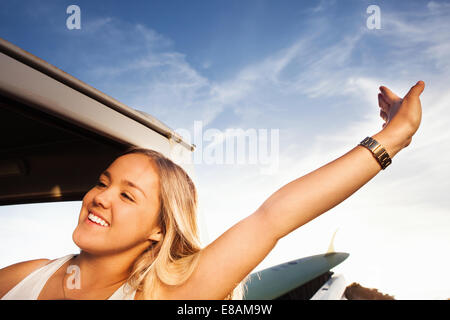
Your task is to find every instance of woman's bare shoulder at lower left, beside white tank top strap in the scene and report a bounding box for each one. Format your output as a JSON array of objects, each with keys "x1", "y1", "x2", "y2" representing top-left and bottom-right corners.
[{"x1": 0, "y1": 259, "x2": 51, "y2": 298}]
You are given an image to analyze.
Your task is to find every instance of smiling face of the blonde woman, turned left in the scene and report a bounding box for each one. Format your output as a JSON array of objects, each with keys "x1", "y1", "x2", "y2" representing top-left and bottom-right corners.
[{"x1": 72, "y1": 154, "x2": 161, "y2": 254}]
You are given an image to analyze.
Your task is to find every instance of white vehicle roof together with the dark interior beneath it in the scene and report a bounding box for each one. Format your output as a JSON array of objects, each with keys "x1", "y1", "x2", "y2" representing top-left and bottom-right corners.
[{"x1": 0, "y1": 38, "x2": 195, "y2": 205}]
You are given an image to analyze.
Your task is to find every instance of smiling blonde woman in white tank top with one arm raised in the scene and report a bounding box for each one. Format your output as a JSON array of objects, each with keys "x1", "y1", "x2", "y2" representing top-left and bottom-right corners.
[{"x1": 0, "y1": 81, "x2": 424, "y2": 299}]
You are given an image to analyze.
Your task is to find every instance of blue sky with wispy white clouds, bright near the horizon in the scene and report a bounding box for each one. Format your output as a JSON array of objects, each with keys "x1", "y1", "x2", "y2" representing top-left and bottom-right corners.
[{"x1": 0, "y1": 0, "x2": 450, "y2": 299}]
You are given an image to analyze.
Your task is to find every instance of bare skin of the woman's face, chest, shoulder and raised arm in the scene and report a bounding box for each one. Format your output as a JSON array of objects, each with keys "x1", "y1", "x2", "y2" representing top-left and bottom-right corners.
[{"x1": 0, "y1": 81, "x2": 424, "y2": 299}]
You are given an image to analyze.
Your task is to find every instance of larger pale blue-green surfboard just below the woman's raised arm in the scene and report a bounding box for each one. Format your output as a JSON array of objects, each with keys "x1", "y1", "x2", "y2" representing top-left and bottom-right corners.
[{"x1": 244, "y1": 252, "x2": 349, "y2": 300}]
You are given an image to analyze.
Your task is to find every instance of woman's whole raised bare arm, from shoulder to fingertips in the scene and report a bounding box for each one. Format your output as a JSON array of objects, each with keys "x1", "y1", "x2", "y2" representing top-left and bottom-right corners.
[{"x1": 162, "y1": 81, "x2": 424, "y2": 299}]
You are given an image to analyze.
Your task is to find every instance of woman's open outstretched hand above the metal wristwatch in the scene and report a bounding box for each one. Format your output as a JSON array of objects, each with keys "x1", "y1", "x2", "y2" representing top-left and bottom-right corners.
[{"x1": 378, "y1": 81, "x2": 425, "y2": 151}]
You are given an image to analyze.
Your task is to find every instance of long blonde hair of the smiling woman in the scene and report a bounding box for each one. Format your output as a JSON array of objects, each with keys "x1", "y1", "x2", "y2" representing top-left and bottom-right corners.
[{"x1": 122, "y1": 148, "x2": 244, "y2": 299}]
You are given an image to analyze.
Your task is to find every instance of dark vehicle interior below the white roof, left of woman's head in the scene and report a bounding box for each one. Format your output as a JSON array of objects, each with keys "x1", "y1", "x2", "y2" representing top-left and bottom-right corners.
[{"x1": 0, "y1": 95, "x2": 128, "y2": 205}]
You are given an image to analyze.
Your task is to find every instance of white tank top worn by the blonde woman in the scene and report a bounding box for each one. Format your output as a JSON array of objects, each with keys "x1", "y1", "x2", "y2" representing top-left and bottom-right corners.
[{"x1": 1, "y1": 254, "x2": 136, "y2": 300}]
